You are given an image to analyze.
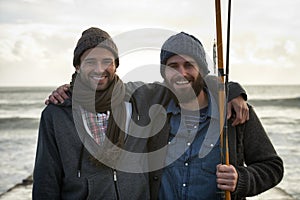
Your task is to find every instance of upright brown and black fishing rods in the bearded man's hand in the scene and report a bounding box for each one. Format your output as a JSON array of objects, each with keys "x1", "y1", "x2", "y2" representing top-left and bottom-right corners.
[{"x1": 215, "y1": 0, "x2": 231, "y2": 200}]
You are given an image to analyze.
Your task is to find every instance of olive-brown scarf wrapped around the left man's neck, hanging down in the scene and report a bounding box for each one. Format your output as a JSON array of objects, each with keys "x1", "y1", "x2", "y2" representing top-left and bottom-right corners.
[{"x1": 70, "y1": 72, "x2": 126, "y2": 147}]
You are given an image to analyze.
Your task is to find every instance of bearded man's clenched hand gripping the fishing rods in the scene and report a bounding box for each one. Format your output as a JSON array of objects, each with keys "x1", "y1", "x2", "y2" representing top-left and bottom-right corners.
[{"x1": 217, "y1": 165, "x2": 238, "y2": 192}]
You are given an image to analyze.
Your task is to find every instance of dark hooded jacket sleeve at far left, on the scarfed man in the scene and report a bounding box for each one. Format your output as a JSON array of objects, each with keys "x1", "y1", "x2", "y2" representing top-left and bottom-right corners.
[{"x1": 32, "y1": 106, "x2": 63, "y2": 200}]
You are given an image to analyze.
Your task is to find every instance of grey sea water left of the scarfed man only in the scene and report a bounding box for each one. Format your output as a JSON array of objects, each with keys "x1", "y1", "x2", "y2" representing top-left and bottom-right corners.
[{"x1": 0, "y1": 87, "x2": 55, "y2": 194}]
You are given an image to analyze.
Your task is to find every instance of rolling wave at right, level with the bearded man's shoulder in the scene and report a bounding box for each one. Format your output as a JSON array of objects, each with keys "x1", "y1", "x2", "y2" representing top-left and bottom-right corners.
[{"x1": 249, "y1": 97, "x2": 300, "y2": 108}]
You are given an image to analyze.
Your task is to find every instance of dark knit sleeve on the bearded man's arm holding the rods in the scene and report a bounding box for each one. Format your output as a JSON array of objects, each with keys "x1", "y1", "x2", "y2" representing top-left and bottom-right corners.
[{"x1": 234, "y1": 107, "x2": 284, "y2": 198}]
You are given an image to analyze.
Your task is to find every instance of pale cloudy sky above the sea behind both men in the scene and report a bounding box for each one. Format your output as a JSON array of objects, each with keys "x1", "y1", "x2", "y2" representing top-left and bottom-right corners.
[{"x1": 0, "y1": 0, "x2": 300, "y2": 87}]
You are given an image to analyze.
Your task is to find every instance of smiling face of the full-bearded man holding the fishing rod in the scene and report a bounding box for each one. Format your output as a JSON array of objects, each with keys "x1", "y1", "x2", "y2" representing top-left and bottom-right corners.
[{"x1": 165, "y1": 55, "x2": 205, "y2": 102}]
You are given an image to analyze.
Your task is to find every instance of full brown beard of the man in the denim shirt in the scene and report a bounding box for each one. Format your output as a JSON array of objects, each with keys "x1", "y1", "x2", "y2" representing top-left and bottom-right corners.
[{"x1": 167, "y1": 74, "x2": 206, "y2": 103}]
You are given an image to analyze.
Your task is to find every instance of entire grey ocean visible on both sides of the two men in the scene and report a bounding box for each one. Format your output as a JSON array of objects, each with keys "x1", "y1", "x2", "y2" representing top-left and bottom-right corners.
[{"x1": 0, "y1": 85, "x2": 300, "y2": 199}]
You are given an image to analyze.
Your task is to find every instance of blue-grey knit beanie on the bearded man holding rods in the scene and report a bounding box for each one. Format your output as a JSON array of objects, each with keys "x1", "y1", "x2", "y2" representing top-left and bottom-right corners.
[{"x1": 160, "y1": 32, "x2": 209, "y2": 78}]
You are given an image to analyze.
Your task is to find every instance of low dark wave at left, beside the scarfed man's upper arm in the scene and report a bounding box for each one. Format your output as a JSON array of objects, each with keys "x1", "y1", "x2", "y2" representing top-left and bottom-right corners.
[{"x1": 0, "y1": 117, "x2": 39, "y2": 130}]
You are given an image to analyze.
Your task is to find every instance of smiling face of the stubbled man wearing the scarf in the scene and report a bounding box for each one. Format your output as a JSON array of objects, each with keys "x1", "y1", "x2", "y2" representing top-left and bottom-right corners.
[{"x1": 76, "y1": 47, "x2": 116, "y2": 90}]
